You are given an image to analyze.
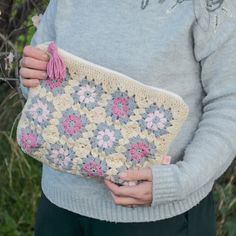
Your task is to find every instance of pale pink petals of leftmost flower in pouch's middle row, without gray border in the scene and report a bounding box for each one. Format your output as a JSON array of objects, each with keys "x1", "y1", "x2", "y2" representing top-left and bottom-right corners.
[{"x1": 29, "y1": 100, "x2": 50, "y2": 123}]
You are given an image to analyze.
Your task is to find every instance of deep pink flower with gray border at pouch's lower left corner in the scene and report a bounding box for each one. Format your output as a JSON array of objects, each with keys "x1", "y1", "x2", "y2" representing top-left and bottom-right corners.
[{"x1": 17, "y1": 128, "x2": 43, "y2": 153}]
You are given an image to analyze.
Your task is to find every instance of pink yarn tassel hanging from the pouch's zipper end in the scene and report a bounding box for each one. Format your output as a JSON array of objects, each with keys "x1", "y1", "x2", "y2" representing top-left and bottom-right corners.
[{"x1": 47, "y1": 42, "x2": 66, "y2": 81}]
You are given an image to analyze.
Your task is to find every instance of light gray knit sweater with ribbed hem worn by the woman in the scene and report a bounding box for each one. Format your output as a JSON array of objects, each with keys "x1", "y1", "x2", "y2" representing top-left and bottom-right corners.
[{"x1": 20, "y1": 0, "x2": 236, "y2": 222}]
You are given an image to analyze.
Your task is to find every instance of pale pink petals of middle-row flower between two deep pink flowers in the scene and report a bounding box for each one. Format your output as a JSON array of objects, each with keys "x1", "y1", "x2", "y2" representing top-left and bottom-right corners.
[{"x1": 97, "y1": 129, "x2": 116, "y2": 148}]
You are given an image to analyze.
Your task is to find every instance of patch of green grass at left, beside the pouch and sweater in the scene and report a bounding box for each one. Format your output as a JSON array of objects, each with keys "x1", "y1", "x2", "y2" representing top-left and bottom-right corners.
[{"x1": 0, "y1": 84, "x2": 41, "y2": 236}]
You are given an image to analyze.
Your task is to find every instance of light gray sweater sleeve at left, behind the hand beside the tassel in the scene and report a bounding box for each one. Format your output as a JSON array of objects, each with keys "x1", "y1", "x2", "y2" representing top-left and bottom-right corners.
[{"x1": 20, "y1": 0, "x2": 57, "y2": 99}]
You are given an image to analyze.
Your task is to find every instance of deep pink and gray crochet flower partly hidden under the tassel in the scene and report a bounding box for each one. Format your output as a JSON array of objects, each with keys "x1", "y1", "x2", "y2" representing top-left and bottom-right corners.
[{"x1": 41, "y1": 71, "x2": 70, "y2": 96}]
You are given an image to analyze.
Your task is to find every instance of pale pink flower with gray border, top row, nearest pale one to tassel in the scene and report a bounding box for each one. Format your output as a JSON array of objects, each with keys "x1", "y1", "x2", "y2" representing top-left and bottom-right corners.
[{"x1": 72, "y1": 76, "x2": 103, "y2": 110}]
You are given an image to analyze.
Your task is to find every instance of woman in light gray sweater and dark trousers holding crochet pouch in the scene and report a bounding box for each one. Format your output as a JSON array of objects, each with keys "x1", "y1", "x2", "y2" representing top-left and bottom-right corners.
[{"x1": 20, "y1": 0, "x2": 236, "y2": 236}]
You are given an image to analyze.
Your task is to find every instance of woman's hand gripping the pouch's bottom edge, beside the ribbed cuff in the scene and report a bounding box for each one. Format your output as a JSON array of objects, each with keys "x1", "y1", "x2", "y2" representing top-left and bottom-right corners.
[{"x1": 105, "y1": 168, "x2": 152, "y2": 207}]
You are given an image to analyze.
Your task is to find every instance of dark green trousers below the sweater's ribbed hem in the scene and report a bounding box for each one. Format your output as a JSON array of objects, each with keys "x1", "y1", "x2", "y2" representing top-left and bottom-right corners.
[{"x1": 35, "y1": 192, "x2": 216, "y2": 236}]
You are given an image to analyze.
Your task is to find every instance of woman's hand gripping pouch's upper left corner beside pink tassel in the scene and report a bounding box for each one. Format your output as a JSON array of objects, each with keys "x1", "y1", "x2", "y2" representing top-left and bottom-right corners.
[{"x1": 20, "y1": 46, "x2": 49, "y2": 88}]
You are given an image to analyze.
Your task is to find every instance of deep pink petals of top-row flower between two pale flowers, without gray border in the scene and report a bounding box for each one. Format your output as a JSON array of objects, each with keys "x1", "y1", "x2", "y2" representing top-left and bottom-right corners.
[{"x1": 112, "y1": 97, "x2": 129, "y2": 117}]
